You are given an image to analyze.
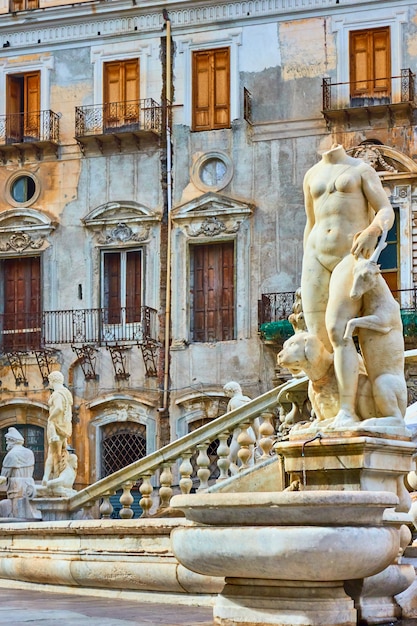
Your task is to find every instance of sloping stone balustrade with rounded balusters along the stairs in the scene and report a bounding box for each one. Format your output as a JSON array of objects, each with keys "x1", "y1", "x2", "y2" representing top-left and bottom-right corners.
[{"x1": 69, "y1": 385, "x2": 283, "y2": 519}]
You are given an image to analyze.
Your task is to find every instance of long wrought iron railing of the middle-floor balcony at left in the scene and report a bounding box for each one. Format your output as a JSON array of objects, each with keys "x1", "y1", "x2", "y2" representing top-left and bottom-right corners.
[{"x1": 0, "y1": 306, "x2": 157, "y2": 352}]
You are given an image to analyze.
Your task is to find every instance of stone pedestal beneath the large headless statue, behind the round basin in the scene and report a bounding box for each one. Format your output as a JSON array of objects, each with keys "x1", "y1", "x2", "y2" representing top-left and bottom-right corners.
[{"x1": 276, "y1": 431, "x2": 415, "y2": 624}]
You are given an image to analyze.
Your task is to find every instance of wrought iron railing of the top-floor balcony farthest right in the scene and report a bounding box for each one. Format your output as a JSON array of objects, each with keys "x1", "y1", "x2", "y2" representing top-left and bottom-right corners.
[{"x1": 322, "y1": 68, "x2": 415, "y2": 112}]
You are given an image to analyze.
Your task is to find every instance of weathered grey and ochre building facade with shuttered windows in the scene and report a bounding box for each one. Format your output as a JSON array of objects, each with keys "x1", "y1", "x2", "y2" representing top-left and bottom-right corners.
[{"x1": 0, "y1": 0, "x2": 417, "y2": 486}]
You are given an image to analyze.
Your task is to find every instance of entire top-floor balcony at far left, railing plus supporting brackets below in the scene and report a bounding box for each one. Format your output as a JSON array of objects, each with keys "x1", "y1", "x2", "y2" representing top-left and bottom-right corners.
[{"x1": 0, "y1": 111, "x2": 60, "y2": 164}]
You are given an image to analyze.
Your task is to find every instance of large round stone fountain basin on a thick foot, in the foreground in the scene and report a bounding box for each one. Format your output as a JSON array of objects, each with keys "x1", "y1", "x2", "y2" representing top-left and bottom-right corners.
[{"x1": 171, "y1": 491, "x2": 400, "y2": 626}]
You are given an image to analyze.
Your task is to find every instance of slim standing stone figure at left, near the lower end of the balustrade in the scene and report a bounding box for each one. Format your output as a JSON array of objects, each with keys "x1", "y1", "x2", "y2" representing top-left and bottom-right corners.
[{"x1": 42, "y1": 371, "x2": 73, "y2": 487}]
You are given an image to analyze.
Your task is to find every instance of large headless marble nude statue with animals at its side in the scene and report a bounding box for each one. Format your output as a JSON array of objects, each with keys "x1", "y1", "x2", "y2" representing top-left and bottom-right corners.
[{"x1": 278, "y1": 145, "x2": 407, "y2": 434}]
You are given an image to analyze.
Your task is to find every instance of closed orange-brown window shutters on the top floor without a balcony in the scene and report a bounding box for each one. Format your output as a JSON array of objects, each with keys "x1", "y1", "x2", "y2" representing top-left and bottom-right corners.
[{"x1": 192, "y1": 48, "x2": 230, "y2": 130}]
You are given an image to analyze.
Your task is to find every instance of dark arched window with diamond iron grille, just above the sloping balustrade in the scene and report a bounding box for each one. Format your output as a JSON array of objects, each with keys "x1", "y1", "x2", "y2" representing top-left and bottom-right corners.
[{"x1": 101, "y1": 422, "x2": 146, "y2": 478}]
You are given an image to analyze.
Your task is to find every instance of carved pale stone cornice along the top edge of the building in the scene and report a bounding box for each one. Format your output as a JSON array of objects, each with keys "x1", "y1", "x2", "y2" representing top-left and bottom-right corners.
[{"x1": 0, "y1": 0, "x2": 348, "y2": 49}]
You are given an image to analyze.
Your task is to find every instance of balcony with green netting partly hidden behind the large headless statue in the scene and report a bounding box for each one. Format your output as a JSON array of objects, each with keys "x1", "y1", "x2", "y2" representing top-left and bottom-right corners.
[{"x1": 258, "y1": 287, "x2": 417, "y2": 349}]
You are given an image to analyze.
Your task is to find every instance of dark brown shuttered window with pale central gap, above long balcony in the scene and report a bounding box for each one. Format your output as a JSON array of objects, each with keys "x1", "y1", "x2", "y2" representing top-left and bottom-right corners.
[{"x1": 102, "y1": 250, "x2": 142, "y2": 324}]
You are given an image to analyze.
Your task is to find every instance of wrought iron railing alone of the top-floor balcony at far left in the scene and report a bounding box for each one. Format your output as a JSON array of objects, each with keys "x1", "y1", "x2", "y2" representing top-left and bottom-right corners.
[{"x1": 0, "y1": 111, "x2": 59, "y2": 146}]
